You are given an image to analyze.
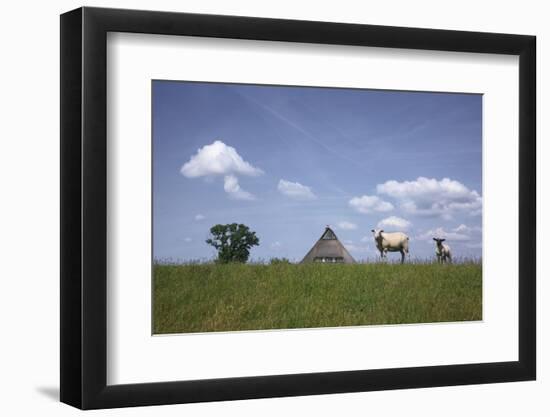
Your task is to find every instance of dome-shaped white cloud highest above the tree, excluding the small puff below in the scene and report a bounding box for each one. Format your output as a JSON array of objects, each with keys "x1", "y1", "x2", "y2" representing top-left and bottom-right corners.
[{"x1": 181, "y1": 140, "x2": 263, "y2": 178}]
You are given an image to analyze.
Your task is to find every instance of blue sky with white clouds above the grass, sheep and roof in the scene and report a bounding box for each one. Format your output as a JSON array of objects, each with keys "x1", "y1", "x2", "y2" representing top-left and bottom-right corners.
[{"x1": 153, "y1": 81, "x2": 482, "y2": 261}]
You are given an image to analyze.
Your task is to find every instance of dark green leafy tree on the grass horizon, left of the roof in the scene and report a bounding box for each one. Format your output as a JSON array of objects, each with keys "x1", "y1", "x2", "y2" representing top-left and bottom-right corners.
[{"x1": 206, "y1": 223, "x2": 260, "y2": 263}]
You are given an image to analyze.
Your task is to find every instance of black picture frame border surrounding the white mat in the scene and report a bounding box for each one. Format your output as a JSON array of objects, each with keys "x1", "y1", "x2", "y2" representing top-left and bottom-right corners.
[{"x1": 60, "y1": 7, "x2": 536, "y2": 409}]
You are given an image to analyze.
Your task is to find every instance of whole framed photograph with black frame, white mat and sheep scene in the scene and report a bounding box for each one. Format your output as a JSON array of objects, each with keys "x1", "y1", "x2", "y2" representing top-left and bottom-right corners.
[{"x1": 61, "y1": 7, "x2": 536, "y2": 409}]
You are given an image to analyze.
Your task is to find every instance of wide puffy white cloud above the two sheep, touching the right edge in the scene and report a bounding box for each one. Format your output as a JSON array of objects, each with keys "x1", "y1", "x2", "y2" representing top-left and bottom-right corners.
[{"x1": 376, "y1": 177, "x2": 482, "y2": 219}]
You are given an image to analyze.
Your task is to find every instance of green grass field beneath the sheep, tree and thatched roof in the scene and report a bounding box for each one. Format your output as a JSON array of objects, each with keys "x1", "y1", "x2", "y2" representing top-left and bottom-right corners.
[{"x1": 153, "y1": 262, "x2": 482, "y2": 334}]
